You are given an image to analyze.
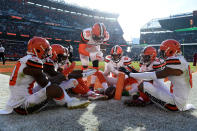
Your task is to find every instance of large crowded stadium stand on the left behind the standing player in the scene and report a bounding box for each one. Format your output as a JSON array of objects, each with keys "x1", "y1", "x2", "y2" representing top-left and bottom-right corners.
[{"x1": 0, "y1": 0, "x2": 126, "y2": 60}]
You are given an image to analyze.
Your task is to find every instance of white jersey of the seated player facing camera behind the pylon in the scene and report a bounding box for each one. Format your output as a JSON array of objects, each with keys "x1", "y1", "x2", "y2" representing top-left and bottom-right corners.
[{"x1": 104, "y1": 55, "x2": 131, "y2": 76}]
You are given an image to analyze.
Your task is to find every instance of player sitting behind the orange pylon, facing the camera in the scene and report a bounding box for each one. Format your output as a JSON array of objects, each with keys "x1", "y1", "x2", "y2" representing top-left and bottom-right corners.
[{"x1": 98, "y1": 45, "x2": 138, "y2": 98}]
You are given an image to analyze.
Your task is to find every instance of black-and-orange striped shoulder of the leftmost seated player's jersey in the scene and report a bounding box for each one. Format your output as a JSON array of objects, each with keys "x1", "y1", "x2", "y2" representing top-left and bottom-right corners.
[{"x1": 26, "y1": 57, "x2": 43, "y2": 69}]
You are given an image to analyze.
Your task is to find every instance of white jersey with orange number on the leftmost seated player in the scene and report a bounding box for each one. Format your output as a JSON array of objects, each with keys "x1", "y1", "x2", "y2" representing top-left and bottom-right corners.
[{"x1": 7, "y1": 55, "x2": 43, "y2": 108}]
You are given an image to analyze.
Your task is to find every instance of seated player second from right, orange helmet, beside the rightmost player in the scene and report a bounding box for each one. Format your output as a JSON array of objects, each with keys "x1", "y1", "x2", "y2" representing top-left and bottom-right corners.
[{"x1": 124, "y1": 46, "x2": 166, "y2": 106}]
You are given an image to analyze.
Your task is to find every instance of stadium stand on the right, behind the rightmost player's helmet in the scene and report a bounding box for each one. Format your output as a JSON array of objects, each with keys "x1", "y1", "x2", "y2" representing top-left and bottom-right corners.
[{"x1": 140, "y1": 11, "x2": 197, "y2": 61}]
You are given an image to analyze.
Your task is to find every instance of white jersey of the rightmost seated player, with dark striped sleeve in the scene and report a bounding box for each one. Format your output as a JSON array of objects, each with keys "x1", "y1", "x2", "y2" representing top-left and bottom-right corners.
[{"x1": 166, "y1": 55, "x2": 192, "y2": 111}]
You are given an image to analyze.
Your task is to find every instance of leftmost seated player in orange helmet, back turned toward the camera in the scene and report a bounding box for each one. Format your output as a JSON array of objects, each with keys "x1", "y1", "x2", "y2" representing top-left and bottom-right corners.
[{"x1": 0, "y1": 37, "x2": 89, "y2": 115}]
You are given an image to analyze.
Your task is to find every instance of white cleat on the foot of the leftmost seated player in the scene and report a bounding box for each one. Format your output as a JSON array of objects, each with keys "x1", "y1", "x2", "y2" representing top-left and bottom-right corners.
[{"x1": 67, "y1": 98, "x2": 90, "y2": 109}]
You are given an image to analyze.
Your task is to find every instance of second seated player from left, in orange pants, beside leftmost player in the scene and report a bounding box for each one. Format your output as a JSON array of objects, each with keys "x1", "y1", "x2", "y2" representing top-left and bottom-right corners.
[{"x1": 47, "y1": 44, "x2": 106, "y2": 100}]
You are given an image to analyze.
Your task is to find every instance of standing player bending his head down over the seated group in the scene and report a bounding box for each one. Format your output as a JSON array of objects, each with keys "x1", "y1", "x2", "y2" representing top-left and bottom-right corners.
[{"x1": 78, "y1": 23, "x2": 109, "y2": 88}]
